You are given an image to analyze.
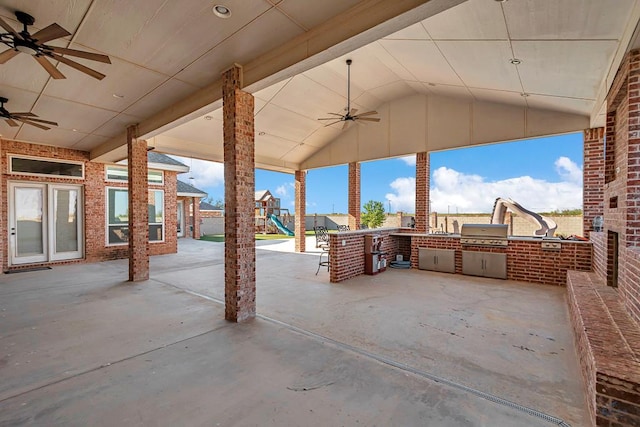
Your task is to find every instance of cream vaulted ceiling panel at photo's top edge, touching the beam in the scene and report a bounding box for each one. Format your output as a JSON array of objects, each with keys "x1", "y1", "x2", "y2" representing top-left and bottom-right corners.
[{"x1": 424, "y1": 0, "x2": 508, "y2": 40}]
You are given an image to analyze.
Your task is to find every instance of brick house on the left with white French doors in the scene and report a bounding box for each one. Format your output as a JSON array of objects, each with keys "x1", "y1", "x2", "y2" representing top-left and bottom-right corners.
[{"x1": 0, "y1": 140, "x2": 206, "y2": 271}]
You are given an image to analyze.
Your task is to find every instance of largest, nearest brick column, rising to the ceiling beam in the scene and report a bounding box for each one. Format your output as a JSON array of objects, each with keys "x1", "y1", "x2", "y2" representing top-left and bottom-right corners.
[{"x1": 222, "y1": 66, "x2": 256, "y2": 322}]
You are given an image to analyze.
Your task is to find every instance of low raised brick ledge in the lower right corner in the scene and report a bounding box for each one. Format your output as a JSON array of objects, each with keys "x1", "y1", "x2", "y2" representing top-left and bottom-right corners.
[{"x1": 567, "y1": 271, "x2": 640, "y2": 426}]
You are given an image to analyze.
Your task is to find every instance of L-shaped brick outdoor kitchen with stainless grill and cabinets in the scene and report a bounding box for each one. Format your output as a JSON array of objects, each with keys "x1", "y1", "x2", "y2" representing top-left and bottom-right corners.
[{"x1": 330, "y1": 224, "x2": 592, "y2": 286}]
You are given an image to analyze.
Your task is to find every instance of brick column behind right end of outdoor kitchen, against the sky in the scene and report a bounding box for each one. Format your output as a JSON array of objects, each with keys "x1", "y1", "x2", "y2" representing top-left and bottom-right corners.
[{"x1": 582, "y1": 128, "x2": 604, "y2": 238}]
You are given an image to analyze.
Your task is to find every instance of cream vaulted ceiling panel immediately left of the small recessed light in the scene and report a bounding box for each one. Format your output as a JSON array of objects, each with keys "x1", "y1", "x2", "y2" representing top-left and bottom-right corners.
[{"x1": 437, "y1": 40, "x2": 521, "y2": 91}]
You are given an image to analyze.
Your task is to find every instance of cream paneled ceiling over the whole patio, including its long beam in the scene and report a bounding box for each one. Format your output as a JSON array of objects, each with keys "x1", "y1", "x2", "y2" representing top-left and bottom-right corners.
[{"x1": 0, "y1": 0, "x2": 640, "y2": 171}]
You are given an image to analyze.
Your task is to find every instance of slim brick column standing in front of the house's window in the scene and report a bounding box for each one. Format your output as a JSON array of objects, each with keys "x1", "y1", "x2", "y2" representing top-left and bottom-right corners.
[{"x1": 127, "y1": 125, "x2": 149, "y2": 282}]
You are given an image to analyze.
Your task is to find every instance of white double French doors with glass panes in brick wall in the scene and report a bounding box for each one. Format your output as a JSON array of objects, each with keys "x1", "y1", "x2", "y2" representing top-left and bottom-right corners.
[{"x1": 9, "y1": 182, "x2": 83, "y2": 264}]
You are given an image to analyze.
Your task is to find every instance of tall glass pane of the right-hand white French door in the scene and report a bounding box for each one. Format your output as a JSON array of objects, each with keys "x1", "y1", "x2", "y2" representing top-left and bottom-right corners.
[{"x1": 54, "y1": 189, "x2": 78, "y2": 253}]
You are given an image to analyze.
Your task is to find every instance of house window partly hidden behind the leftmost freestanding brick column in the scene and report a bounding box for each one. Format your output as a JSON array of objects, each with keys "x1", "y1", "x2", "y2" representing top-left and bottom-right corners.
[{"x1": 107, "y1": 188, "x2": 164, "y2": 245}]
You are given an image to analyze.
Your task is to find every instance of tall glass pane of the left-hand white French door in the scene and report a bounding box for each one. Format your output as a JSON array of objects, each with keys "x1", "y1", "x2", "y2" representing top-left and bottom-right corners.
[{"x1": 14, "y1": 188, "x2": 44, "y2": 256}]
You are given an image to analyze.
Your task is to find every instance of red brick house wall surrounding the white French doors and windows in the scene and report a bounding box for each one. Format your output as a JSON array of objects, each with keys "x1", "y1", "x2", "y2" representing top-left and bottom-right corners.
[{"x1": 0, "y1": 140, "x2": 177, "y2": 270}]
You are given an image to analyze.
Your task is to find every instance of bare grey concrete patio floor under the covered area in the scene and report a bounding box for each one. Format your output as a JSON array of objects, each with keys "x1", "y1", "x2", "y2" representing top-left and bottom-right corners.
[{"x1": 0, "y1": 239, "x2": 589, "y2": 426}]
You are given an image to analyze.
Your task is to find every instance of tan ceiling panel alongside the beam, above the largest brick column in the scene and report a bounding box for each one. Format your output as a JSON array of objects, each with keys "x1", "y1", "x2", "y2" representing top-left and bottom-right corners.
[{"x1": 176, "y1": 9, "x2": 303, "y2": 86}]
